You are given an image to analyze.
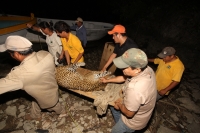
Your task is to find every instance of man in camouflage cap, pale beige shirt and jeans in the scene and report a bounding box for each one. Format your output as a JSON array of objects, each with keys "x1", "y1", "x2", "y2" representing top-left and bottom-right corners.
[{"x1": 101, "y1": 48, "x2": 157, "y2": 133}]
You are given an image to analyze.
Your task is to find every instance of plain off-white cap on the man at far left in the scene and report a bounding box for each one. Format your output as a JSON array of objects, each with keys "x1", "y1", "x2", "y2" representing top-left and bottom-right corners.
[{"x1": 0, "y1": 35, "x2": 32, "y2": 52}]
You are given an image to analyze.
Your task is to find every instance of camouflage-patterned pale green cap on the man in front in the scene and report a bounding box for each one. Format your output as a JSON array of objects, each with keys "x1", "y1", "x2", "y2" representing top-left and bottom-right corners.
[{"x1": 113, "y1": 48, "x2": 148, "y2": 69}]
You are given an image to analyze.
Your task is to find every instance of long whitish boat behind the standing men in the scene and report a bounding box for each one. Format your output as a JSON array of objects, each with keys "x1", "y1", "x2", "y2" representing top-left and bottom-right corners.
[{"x1": 26, "y1": 18, "x2": 114, "y2": 42}]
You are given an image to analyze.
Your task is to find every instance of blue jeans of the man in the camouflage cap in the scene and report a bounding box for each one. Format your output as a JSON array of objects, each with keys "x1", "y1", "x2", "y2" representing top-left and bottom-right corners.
[{"x1": 110, "y1": 107, "x2": 135, "y2": 133}]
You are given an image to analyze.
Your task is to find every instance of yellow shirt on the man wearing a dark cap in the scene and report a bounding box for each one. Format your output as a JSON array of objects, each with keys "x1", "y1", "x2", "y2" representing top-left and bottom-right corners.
[{"x1": 154, "y1": 57, "x2": 185, "y2": 95}]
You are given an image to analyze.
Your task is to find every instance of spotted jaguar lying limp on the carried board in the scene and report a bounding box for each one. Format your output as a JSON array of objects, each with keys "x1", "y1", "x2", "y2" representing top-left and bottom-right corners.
[{"x1": 55, "y1": 63, "x2": 112, "y2": 92}]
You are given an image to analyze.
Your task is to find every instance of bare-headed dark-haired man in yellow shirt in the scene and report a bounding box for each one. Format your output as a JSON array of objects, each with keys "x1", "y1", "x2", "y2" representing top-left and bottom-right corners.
[{"x1": 54, "y1": 21, "x2": 84, "y2": 65}]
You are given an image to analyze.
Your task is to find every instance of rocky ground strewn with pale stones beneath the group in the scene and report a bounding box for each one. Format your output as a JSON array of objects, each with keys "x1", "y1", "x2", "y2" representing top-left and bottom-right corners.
[{"x1": 0, "y1": 37, "x2": 200, "y2": 133}]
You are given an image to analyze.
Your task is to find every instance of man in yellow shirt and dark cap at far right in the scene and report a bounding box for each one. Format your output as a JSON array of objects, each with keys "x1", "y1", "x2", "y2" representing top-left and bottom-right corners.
[{"x1": 148, "y1": 47, "x2": 185, "y2": 100}]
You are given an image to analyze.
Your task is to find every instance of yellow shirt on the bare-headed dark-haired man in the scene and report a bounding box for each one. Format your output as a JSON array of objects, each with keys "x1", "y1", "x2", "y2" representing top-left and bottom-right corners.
[{"x1": 61, "y1": 33, "x2": 84, "y2": 63}]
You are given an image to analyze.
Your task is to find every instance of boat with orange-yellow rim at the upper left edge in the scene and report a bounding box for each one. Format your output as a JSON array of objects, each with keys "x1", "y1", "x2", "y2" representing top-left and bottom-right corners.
[{"x1": 0, "y1": 13, "x2": 37, "y2": 44}]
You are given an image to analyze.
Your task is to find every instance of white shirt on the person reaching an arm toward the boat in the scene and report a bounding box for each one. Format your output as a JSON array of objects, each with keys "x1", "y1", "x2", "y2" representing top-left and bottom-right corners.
[{"x1": 40, "y1": 29, "x2": 62, "y2": 65}]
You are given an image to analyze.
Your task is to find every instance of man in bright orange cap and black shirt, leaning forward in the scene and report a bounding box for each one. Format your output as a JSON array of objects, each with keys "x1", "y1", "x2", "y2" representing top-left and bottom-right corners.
[{"x1": 101, "y1": 25, "x2": 138, "y2": 76}]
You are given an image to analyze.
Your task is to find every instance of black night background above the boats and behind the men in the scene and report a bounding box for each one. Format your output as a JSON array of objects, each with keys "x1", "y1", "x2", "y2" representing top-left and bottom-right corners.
[{"x1": 0, "y1": 0, "x2": 200, "y2": 74}]
